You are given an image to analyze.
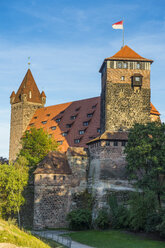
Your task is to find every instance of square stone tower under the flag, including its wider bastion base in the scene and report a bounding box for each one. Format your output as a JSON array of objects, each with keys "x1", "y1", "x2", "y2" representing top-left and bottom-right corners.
[{"x1": 88, "y1": 46, "x2": 153, "y2": 211}]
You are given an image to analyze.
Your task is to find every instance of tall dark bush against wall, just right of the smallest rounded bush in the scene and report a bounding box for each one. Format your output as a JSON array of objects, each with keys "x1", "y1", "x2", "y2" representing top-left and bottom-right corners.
[{"x1": 109, "y1": 195, "x2": 129, "y2": 229}]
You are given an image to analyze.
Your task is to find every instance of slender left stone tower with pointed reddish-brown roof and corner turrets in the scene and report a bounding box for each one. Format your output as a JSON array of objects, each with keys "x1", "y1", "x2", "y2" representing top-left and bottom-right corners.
[{"x1": 9, "y1": 69, "x2": 46, "y2": 161}]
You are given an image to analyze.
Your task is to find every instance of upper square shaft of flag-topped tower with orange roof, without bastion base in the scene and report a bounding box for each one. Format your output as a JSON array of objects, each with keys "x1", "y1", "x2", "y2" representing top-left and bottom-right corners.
[{"x1": 100, "y1": 46, "x2": 153, "y2": 133}]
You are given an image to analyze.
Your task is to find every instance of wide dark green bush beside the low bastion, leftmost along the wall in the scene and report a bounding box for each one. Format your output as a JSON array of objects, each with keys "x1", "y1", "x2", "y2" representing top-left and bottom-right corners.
[{"x1": 67, "y1": 209, "x2": 92, "y2": 230}]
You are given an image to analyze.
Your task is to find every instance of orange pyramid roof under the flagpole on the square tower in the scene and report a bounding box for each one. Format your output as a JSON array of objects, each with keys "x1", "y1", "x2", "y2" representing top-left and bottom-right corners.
[{"x1": 105, "y1": 45, "x2": 153, "y2": 62}]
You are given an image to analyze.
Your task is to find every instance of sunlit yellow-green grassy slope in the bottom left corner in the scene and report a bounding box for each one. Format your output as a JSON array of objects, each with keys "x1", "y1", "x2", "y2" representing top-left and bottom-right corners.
[{"x1": 0, "y1": 219, "x2": 63, "y2": 248}]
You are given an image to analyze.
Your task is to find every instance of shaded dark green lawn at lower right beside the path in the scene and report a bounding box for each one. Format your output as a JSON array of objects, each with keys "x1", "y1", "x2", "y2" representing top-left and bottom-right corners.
[{"x1": 67, "y1": 230, "x2": 165, "y2": 248}]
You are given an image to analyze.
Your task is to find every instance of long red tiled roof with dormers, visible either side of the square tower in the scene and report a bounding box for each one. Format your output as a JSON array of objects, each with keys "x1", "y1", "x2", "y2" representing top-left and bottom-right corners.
[{"x1": 27, "y1": 97, "x2": 159, "y2": 152}]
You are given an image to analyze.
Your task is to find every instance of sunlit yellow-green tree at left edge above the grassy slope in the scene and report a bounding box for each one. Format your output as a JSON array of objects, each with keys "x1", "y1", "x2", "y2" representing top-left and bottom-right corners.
[{"x1": 0, "y1": 156, "x2": 28, "y2": 226}]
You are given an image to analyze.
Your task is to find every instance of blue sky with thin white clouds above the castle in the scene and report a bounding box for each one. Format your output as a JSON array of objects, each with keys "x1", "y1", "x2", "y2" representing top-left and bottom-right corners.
[{"x1": 0, "y1": 0, "x2": 165, "y2": 157}]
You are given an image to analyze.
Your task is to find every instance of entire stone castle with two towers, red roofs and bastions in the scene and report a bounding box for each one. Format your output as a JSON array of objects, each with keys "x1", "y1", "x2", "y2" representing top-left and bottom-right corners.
[{"x1": 9, "y1": 46, "x2": 160, "y2": 228}]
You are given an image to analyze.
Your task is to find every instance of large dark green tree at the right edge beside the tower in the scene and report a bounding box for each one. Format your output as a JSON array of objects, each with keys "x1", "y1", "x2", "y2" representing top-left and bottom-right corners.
[{"x1": 125, "y1": 122, "x2": 165, "y2": 207}]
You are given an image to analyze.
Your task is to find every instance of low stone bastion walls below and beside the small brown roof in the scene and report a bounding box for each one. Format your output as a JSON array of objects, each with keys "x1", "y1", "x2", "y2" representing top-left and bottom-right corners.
[{"x1": 33, "y1": 148, "x2": 89, "y2": 229}]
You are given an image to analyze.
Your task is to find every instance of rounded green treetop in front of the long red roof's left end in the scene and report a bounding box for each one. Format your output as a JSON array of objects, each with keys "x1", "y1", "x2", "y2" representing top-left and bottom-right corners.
[{"x1": 19, "y1": 128, "x2": 58, "y2": 169}]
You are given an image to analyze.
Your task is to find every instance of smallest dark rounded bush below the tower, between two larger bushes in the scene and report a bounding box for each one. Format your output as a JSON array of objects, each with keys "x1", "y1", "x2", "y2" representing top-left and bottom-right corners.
[{"x1": 94, "y1": 209, "x2": 109, "y2": 230}]
